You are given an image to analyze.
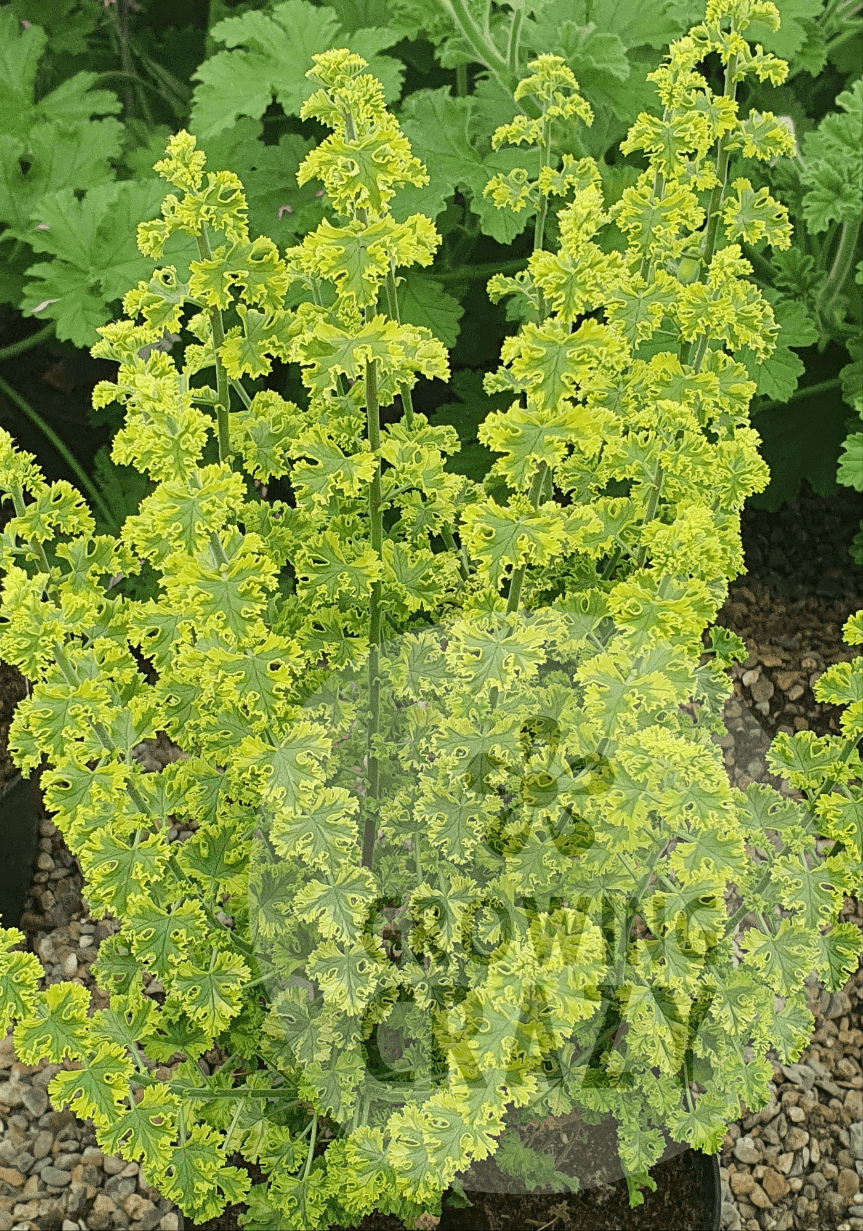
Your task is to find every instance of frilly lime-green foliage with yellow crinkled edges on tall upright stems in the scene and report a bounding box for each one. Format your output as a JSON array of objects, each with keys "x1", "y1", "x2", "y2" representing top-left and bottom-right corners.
[{"x1": 0, "y1": 0, "x2": 863, "y2": 1231}]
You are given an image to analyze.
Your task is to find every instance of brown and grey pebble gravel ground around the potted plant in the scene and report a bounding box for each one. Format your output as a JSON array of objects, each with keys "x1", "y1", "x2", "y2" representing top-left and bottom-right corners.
[{"x1": 0, "y1": 482, "x2": 863, "y2": 1231}]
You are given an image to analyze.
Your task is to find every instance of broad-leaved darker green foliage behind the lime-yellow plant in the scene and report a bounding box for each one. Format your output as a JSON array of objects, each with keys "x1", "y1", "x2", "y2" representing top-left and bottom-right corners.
[{"x1": 0, "y1": 0, "x2": 863, "y2": 549}]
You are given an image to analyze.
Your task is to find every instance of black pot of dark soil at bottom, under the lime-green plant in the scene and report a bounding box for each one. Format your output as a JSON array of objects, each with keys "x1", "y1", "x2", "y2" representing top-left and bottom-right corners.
[{"x1": 438, "y1": 1113, "x2": 721, "y2": 1231}]
